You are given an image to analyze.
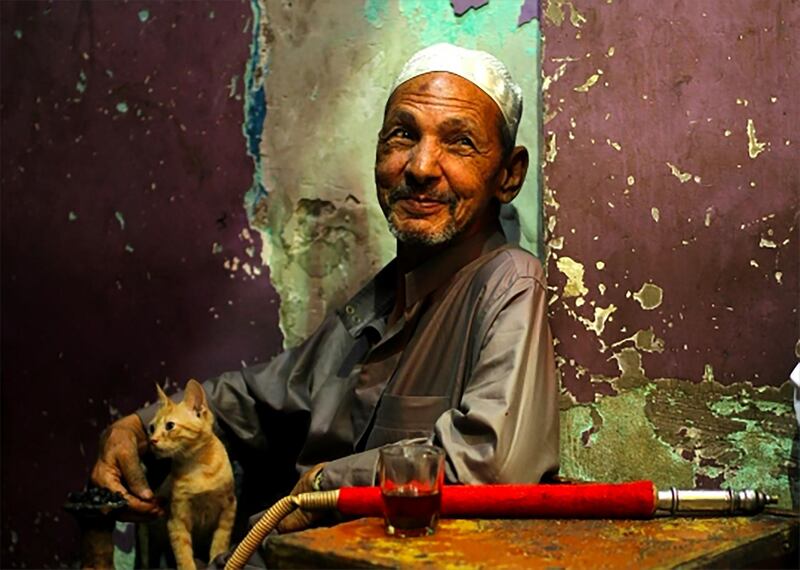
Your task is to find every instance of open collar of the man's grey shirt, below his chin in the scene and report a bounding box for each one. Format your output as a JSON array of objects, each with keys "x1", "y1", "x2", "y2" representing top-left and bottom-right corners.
[{"x1": 337, "y1": 226, "x2": 506, "y2": 337}]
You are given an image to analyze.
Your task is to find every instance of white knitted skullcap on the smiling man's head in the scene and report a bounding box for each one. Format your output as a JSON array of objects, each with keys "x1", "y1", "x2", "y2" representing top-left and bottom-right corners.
[{"x1": 392, "y1": 43, "x2": 522, "y2": 140}]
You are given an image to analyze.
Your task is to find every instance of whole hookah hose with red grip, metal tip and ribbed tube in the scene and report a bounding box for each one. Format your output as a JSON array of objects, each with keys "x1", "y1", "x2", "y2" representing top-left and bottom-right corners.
[{"x1": 225, "y1": 481, "x2": 778, "y2": 570}]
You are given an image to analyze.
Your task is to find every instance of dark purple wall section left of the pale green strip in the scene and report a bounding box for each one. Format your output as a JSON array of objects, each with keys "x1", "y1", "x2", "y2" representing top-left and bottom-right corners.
[{"x1": 0, "y1": 1, "x2": 281, "y2": 568}]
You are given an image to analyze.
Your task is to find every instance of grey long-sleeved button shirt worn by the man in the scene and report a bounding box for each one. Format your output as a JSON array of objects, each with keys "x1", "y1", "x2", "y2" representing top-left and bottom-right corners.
[{"x1": 139, "y1": 226, "x2": 559, "y2": 496}]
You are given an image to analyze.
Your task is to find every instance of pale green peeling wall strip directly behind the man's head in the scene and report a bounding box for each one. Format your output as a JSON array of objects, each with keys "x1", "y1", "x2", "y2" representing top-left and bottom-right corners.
[{"x1": 246, "y1": 0, "x2": 541, "y2": 346}]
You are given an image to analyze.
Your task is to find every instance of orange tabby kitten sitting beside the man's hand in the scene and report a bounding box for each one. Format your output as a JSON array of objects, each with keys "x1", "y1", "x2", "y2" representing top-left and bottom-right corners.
[{"x1": 148, "y1": 380, "x2": 236, "y2": 569}]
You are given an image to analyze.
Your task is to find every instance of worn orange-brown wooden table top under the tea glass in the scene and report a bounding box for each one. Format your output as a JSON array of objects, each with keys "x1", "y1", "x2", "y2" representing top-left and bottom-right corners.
[{"x1": 267, "y1": 515, "x2": 800, "y2": 570}]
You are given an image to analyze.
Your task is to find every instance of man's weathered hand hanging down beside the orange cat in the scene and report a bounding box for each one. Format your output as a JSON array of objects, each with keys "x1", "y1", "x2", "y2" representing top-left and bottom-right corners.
[{"x1": 92, "y1": 414, "x2": 164, "y2": 520}]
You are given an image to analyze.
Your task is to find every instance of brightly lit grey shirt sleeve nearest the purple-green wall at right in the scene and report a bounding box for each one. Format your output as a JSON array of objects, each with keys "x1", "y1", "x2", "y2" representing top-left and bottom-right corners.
[{"x1": 435, "y1": 276, "x2": 559, "y2": 484}]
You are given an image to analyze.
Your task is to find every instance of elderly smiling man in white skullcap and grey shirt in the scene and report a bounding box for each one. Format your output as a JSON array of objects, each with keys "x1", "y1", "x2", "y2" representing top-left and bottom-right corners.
[{"x1": 93, "y1": 44, "x2": 558, "y2": 531}]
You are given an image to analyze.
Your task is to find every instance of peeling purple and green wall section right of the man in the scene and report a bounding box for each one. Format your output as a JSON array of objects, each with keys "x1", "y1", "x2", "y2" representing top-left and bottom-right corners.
[{"x1": 542, "y1": 0, "x2": 800, "y2": 506}]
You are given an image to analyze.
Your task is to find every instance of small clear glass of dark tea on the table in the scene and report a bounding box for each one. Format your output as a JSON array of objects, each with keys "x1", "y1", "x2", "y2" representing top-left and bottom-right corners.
[{"x1": 379, "y1": 444, "x2": 444, "y2": 537}]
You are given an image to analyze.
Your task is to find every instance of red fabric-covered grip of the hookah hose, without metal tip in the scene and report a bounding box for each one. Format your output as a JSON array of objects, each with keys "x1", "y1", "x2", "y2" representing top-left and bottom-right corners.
[{"x1": 337, "y1": 481, "x2": 658, "y2": 519}]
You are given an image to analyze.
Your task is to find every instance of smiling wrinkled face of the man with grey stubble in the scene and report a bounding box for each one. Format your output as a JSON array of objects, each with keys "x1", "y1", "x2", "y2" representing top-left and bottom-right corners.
[{"x1": 375, "y1": 72, "x2": 503, "y2": 245}]
